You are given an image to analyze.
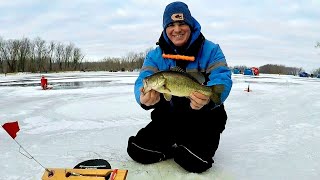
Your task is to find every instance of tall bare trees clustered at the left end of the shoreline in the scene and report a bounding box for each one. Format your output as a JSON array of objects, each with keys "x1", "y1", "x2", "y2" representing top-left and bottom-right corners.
[{"x1": 0, "y1": 37, "x2": 84, "y2": 73}]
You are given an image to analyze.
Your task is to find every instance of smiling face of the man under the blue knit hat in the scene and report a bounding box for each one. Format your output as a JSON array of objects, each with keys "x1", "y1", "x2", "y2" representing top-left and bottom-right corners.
[{"x1": 166, "y1": 21, "x2": 191, "y2": 47}]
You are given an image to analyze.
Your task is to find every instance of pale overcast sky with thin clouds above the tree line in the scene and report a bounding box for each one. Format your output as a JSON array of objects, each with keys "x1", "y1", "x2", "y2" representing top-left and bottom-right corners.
[{"x1": 0, "y1": 0, "x2": 320, "y2": 71}]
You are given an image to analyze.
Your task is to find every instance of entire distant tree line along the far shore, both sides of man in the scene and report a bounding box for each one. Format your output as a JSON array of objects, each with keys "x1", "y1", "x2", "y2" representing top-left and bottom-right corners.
[{"x1": 0, "y1": 37, "x2": 320, "y2": 75}]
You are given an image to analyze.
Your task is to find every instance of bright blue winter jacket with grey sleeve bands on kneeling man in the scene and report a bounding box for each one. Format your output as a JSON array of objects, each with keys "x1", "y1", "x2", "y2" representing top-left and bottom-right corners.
[{"x1": 134, "y1": 19, "x2": 232, "y2": 107}]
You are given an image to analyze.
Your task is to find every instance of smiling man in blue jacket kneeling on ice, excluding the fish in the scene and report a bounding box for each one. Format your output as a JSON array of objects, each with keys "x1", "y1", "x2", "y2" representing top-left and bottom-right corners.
[{"x1": 127, "y1": 2, "x2": 232, "y2": 173}]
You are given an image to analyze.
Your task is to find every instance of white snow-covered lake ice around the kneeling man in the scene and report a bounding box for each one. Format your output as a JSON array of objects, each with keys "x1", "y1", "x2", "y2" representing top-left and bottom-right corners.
[{"x1": 0, "y1": 72, "x2": 320, "y2": 180}]
